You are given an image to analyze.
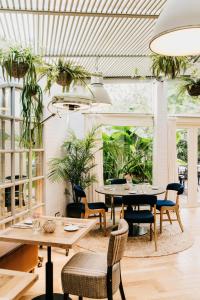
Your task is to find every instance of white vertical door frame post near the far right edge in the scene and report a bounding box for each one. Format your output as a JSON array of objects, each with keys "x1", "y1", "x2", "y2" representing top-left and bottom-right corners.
[{"x1": 188, "y1": 128, "x2": 198, "y2": 207}]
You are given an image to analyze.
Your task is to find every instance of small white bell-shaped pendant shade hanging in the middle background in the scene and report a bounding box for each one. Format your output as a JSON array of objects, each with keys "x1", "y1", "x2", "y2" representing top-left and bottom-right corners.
[{"x1": 91, "y1": 75, "x2": 112, "y2": 106}]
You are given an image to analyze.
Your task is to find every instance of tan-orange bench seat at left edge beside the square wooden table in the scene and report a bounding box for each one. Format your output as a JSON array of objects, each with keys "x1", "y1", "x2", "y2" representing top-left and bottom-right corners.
[{"x1": 0, "y1": 241, "x2": 38, "y2": 272}]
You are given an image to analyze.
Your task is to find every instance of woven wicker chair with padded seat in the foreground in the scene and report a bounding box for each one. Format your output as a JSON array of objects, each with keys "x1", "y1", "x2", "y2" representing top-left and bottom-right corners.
[{"x1": 61, "y1": 219, "x2": 128, "y2": 300}]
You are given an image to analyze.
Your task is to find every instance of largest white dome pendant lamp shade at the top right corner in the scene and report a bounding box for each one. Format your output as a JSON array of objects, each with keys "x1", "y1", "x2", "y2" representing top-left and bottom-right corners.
[{"x1": 150, "y1": 0, "x2": 200, "y2": 56}]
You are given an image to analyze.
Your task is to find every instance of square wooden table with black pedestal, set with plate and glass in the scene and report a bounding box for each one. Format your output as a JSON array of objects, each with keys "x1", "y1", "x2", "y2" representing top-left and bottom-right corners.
[{"x1": 0, "y1": 216, "x2": 96, "y2": 300}]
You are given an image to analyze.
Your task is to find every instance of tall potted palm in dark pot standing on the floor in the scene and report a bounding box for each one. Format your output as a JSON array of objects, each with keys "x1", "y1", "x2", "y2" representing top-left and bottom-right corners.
[{"x1": 49, "y1": 127, "x2": 99, "y2": 217}]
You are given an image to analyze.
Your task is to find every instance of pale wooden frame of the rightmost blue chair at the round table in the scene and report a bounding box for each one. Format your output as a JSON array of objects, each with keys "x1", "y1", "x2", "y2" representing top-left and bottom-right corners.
[{"x1": 159, "y1": 190, "x2": 184, "y2": 233}]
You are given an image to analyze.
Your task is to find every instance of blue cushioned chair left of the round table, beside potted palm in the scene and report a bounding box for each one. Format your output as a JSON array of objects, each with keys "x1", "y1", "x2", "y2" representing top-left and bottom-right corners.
[{"x1": 73, "y1": 185, "x2": 108, "y2": 234}]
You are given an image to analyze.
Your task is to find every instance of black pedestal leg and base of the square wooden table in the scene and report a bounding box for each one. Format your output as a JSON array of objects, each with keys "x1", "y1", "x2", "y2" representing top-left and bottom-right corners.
[{"x1": 33, "y1": 246, "x2": 71, "y2": 300}]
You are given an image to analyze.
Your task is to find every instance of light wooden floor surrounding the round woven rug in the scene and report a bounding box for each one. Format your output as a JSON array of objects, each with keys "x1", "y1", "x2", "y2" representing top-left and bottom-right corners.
[{"x1": 20, "y1": 208, "x2": 200, "y2": 300}]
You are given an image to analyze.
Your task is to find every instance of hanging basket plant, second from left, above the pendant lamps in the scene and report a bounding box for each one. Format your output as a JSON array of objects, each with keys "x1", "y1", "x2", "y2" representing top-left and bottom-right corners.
[{"x1": 39, "y1": 59, "x2": 90, "y2": 92}]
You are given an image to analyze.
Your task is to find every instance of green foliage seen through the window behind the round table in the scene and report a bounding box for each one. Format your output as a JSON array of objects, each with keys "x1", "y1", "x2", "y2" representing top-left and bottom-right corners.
[{"x1": 103, "y1": 126, "x2": 152, "y2": 183}]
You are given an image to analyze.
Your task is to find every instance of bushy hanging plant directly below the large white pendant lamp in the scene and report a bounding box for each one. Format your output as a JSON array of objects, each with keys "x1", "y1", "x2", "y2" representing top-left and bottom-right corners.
[{"x1": 151, "y1": 54, "x2": 189, "y2": 79}]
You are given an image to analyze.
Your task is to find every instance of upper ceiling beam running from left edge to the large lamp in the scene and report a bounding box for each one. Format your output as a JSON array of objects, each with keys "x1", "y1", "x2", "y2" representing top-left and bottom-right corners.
[{"x1": 0, "y1": 8, "x2": 159, "y2": 19}]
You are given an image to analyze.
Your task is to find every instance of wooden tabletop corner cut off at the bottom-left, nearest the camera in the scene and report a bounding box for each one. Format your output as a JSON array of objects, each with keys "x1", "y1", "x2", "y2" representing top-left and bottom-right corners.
[{"x1": 0, "y1": 269, "x2": 38, "y2": 300}]
